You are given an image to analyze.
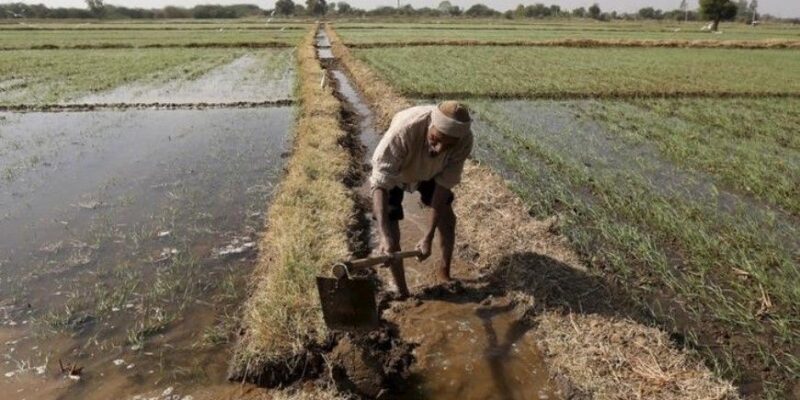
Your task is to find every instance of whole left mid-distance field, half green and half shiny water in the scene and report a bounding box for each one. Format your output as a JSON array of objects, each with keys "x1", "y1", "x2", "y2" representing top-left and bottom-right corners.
[{"x1": 0, "y1": 49, "x2": 293, "y2": 105}]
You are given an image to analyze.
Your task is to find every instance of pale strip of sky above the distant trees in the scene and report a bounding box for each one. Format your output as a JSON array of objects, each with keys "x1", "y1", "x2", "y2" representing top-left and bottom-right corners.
[{"x1": 10, "y1": 0, "x2": 800, "y2": 18}]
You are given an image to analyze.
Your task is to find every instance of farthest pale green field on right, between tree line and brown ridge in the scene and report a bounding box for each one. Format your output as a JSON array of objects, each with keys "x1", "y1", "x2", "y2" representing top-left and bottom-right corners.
[{"x1": 336, "y1": 22, "x2": 800, "y2": 44}]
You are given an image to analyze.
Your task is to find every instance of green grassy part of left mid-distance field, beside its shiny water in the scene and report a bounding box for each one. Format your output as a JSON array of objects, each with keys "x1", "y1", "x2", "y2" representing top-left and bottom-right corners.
[{"x1": 0, "y1": 49, "x2": 292, "y2": 105}]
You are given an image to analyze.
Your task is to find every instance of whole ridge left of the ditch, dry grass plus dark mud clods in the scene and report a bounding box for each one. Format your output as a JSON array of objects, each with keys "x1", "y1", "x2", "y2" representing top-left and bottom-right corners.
[{"x1": 229, "y1": 25, "x2": 413, "y2": 398}]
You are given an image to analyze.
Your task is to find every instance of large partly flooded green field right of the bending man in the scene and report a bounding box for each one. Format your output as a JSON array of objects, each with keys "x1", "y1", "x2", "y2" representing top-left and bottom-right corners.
[{"x1": 470, "y1": 99, "x2": 800, "y2": 393}]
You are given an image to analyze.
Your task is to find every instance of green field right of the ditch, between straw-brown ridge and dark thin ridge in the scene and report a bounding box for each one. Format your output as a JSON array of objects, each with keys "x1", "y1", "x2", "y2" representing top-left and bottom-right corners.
[{"x1": 355, "y1": 46, "x2": 800, "y2": 98}]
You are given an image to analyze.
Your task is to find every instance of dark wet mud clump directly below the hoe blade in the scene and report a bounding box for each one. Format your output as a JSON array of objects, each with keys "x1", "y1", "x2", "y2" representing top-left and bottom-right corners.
[{"x1": 331, "y1": 327, "x2": 414, "y2": 399}]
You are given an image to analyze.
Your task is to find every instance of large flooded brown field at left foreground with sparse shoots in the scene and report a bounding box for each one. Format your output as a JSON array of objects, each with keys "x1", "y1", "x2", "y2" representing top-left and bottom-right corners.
[{"x1": 0, "y1": 107, "x2": 293, "y2": 399}]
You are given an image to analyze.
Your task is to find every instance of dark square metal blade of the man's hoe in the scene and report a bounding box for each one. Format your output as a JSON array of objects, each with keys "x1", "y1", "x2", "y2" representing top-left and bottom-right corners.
[{"x1": 317, "y1": 276, "x2": 379, "y2": 331}]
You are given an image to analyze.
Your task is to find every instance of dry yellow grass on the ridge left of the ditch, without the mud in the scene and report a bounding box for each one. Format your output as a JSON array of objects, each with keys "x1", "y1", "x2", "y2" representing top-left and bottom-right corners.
[{"x1": 232, "y1": 31, "x2": 354, "y2": 375}]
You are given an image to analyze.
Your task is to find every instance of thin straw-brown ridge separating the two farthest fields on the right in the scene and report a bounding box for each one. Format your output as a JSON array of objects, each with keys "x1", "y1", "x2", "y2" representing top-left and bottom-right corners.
[{"x1": 348, "y1": 39, "x2": 800, "y2": 49}]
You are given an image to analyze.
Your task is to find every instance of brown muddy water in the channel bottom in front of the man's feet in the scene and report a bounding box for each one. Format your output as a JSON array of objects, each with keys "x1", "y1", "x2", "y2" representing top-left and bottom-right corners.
[{"x1": 388, "y1": 300, "x2": 559, "y2": 400}]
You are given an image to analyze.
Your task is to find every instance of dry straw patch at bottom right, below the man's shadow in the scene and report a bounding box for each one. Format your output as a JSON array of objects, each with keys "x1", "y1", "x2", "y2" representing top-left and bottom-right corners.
[{"x1": 535, "y1": 312, "x2": 738, "y2": 400}]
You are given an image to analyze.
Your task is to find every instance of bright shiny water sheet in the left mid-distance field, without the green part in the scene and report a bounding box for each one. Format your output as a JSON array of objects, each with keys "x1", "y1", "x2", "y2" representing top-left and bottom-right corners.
[{"x1": 73, "y1": 50, "x2": 294, "y2": 104}]
